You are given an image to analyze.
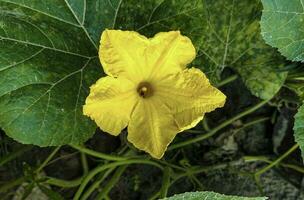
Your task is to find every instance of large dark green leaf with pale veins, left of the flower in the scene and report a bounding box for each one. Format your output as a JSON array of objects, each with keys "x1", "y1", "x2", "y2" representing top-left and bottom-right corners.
[{"x1": 0, "y1": 0, "x2": 120, "y2": 146}]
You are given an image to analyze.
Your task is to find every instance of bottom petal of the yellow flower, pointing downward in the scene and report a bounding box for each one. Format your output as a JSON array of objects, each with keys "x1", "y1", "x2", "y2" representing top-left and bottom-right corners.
[{"x1": 128, "y1": 97, "x2": 179, "y2": 159}]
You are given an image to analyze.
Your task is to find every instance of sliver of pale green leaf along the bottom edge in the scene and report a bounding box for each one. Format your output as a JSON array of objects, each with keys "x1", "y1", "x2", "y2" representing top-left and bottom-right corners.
[{"x1": 164, "y1": 192, "x2": 267, "y2": 200}]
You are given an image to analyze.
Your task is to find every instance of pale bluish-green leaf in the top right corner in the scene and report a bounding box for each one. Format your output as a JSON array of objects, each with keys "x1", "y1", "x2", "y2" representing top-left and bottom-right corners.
[{"x1": 261, "y1": 0, "x2": 304, "y2": 62}]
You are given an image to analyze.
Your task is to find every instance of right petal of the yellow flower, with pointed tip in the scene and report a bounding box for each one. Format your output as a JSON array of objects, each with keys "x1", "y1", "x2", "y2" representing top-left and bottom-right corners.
[{"x1": 155, "y1": 68, "x2": 226, "y2": 131}]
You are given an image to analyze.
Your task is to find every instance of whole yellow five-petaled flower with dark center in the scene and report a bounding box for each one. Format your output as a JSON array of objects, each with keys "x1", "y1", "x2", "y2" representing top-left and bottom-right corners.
[{"x1": 83, "y1": 30, "x2": 226, "y2": 158}]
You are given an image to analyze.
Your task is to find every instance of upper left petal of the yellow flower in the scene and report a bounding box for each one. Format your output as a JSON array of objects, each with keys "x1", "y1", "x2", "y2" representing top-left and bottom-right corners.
[{"x1": 99, "y1": 30, "x2": 149, "y2": 80}]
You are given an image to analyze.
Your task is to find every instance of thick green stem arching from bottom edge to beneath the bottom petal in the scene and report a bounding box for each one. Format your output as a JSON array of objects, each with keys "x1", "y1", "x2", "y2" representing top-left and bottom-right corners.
[{"x1": 73, "y1": 159, "x2": 163, "y2": 200}]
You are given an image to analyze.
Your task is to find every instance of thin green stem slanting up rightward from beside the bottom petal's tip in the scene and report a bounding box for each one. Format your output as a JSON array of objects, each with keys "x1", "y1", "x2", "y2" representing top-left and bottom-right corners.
[{"x1": 168, "y1": 100, "x2": 269, "y2": 150}]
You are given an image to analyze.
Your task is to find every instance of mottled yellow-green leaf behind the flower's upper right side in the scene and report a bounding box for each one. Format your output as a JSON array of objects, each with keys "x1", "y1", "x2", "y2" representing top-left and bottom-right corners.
[{"x1": 115, "y1": 0, "x2": 287, "y2": 99}]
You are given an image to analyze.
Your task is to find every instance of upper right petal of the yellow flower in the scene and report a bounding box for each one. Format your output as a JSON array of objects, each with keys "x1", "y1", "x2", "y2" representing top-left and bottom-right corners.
[{"x1": 147, "y1": 31, "x2": 196, "y2": 77}]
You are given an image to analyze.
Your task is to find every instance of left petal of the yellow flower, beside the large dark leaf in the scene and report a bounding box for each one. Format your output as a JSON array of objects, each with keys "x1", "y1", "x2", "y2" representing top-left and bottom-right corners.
[{"x1": 83, "y1": 76, "x2": 138, "y2": 135}]
